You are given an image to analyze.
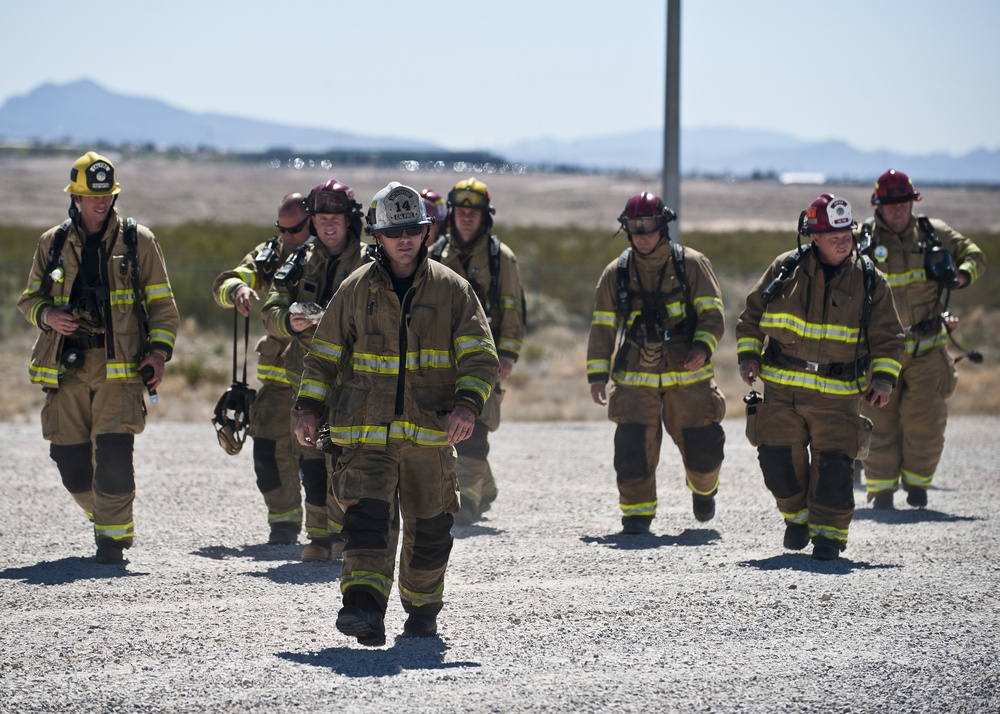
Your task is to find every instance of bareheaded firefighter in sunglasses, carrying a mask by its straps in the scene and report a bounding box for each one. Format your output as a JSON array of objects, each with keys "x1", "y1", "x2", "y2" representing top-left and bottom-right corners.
[{"x1": 212, "y1": 193, "x2": 311, "y2": 545}]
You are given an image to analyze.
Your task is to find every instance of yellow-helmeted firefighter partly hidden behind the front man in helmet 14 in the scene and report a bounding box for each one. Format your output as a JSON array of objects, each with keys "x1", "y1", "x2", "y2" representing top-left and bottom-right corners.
[{"x1": 430, "y1": 178, "x2": 525, "y2": 525}]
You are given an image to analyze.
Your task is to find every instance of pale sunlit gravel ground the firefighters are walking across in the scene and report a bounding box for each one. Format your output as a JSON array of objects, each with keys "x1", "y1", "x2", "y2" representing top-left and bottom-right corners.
[{"x1": 0, "y1": 417, "x2": 1000, "y2": 712}]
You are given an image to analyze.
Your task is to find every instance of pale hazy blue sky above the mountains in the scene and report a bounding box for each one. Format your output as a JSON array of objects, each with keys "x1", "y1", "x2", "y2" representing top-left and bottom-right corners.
[{"x1": 0, "y1": 0, "x2": 1000, "y2": 154}]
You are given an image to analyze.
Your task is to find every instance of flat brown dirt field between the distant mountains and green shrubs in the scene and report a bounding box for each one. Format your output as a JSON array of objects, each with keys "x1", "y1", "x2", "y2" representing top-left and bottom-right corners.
[{"x1": 0, "y1": 153, "x2": 1000, "y2": 232}]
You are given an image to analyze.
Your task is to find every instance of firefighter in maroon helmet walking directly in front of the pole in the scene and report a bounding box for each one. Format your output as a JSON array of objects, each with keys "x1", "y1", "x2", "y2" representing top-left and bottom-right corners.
[{"x1": 587, "y1": 192, "x2": 726, "y2": 534}]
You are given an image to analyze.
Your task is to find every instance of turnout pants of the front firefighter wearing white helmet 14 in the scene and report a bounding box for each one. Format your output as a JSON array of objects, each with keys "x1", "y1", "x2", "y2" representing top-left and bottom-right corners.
[{"x1": 333, "y1": 440, "x2": 459, "y2": 613}]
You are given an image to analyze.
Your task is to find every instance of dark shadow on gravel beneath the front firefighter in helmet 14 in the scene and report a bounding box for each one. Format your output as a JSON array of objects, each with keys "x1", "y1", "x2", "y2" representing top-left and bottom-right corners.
[{"x1": 275, "y1": 637, "x2": 482, "y2": 677}]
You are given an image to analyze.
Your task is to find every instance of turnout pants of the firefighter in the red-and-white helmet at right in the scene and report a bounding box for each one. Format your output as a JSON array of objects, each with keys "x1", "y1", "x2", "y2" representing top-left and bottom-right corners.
[{"x1": 747, "y1": 382, "x2": 871, "y2": 550}]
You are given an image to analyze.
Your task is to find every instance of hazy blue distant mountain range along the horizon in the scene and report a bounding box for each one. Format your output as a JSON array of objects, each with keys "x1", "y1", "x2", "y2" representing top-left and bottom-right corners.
[{"x1": 0, "y1": 80, "x2": 1000, "y2": 184}]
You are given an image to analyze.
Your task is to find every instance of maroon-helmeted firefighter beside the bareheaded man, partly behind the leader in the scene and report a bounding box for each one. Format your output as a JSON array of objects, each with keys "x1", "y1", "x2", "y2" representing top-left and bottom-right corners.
[{"x1": 261, "y1": 179, "x2": 367, "y2": 562}]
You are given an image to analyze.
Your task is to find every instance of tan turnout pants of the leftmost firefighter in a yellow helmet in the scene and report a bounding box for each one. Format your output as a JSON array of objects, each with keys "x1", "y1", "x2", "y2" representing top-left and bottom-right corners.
[{"x1": 42, "y1": 347, "x2": 146, "y2": 548}]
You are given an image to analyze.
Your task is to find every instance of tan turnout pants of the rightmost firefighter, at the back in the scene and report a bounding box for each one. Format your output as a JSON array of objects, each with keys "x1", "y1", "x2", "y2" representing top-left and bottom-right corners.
[{"x1": 862, "y1": 347, "x2": 958, "y2": 494}]
